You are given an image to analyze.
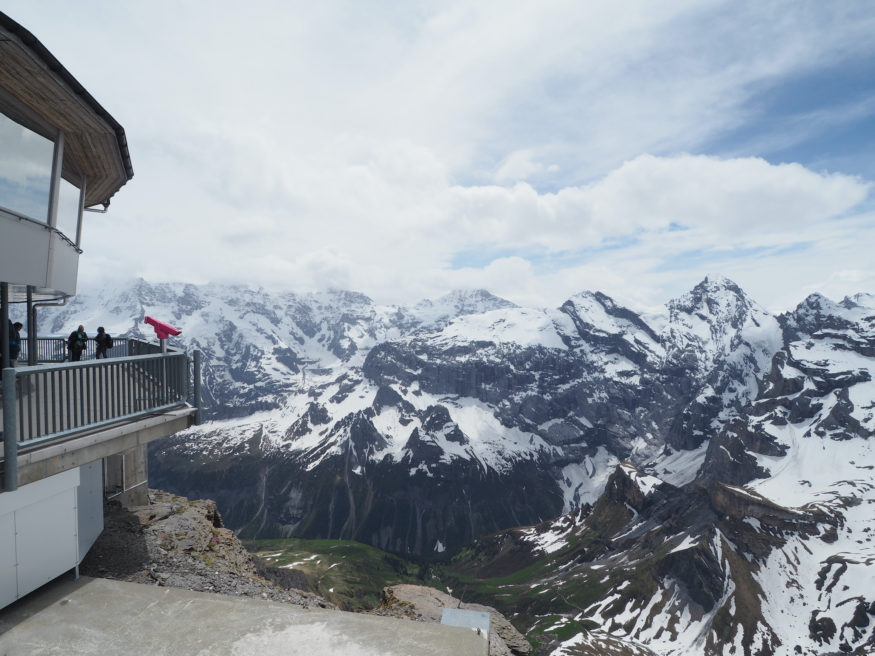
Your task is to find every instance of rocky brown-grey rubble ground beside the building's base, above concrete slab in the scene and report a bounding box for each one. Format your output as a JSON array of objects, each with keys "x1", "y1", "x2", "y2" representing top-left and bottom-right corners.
[{"x1": 80, "y1": 490, "x2": 334, "y2": 608}]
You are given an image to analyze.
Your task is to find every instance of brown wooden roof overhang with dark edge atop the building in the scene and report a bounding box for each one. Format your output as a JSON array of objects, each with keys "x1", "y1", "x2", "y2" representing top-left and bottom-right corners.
[{"x1": 0, "y1": 12, "x2": 134, "y2": 207}]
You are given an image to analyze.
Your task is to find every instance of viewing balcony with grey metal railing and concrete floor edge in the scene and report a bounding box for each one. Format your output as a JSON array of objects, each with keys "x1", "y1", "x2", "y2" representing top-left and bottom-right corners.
[{"x1": 0, "y1": 337, "x2": 198, "y2": 491}]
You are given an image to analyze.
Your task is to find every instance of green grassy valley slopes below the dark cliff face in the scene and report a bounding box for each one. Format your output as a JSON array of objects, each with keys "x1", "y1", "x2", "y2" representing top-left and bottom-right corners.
[{"x1": 245, "y1": 500, "x2": 653, "y2": 653}]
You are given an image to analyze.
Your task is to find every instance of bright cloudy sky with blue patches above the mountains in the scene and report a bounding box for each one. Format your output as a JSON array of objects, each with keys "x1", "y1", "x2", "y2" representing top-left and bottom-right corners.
[{"x1": 3, "y1": 0, "x2": 875, "y2": 310}]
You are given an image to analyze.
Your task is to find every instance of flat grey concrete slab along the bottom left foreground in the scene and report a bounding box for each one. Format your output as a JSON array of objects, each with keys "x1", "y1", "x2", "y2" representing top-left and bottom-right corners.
[{"x1": 0, "y1": 577, "x2": 487, "y2": 656}]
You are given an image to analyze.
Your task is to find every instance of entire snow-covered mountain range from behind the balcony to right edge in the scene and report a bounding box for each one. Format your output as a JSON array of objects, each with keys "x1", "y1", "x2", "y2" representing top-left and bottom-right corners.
[{"x1": 36, "y1": 277, "x2": 875, "y2": 655}]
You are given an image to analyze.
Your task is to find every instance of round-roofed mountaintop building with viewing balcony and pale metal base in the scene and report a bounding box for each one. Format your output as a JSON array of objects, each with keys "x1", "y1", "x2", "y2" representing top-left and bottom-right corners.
[{"x1": 0, "y1": 13, "x2": 198, "y2": 608}]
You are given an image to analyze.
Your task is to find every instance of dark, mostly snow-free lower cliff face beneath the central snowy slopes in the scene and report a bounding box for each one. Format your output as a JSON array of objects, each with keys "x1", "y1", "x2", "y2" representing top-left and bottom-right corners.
[{"x1": 152, "y1": 434, "x2": 562, "y2": 554}]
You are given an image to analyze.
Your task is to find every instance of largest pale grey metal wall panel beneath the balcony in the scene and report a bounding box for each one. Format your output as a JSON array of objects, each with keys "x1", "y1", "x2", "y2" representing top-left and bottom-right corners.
[{"x1": 15, "y1": 488, "x2": 78, "y2": 596}]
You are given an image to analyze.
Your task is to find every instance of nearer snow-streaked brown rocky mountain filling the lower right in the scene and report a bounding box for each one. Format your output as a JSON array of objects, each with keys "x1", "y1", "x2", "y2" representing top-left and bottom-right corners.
[{"x1": 448, "y1": 288, "x2": 875, "y2": 656}]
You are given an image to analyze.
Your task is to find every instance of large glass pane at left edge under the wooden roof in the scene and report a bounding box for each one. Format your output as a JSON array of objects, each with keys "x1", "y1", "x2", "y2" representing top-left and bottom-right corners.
[{"x1": 0, "y1": 109, "x2": 55, "y2": 221}]
